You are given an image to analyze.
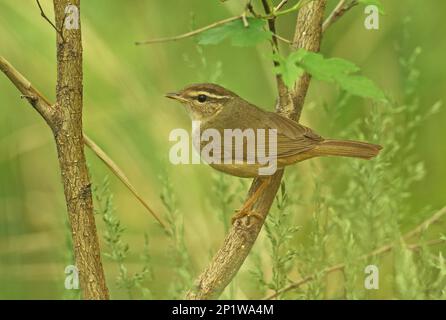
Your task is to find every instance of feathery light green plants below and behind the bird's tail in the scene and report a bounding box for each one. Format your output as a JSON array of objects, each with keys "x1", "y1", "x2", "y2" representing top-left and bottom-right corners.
[{"x1": 251, "y1": 38, "x2": 446, "y2": 299}]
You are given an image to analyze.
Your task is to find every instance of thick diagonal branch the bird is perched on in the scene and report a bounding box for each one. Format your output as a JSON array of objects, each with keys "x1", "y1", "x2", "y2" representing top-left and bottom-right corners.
[{"x1": 186, "y1": 0, "x2": 326, "y2": 300}]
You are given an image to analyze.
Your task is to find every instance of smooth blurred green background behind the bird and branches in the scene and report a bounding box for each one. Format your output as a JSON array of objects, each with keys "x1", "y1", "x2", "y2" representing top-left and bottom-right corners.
[{"x1": 0, "y1": 0, "x2": 446, "y2": 299}]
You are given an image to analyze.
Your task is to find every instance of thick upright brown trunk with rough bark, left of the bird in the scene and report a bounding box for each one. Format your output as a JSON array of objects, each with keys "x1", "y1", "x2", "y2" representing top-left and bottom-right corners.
[{"x1": 52, "y1": 0, "x2": 109, "y2": 299}]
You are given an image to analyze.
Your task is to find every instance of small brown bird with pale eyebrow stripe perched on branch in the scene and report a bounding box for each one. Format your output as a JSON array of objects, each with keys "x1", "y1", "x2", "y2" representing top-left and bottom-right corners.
[{"x1": 166, "y1": 83, "x2": 382, "y2": 221}]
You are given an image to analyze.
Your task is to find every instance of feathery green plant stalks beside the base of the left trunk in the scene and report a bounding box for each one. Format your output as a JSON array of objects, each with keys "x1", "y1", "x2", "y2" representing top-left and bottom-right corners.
[{"x1": 93, "y1": 176, "x2": 153, "y2": 299}]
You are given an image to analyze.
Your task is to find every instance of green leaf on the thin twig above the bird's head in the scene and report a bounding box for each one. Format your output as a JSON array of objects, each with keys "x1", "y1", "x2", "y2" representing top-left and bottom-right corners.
[{"x1": 197, "y1": 18, "x2": 272, "y2": 47}]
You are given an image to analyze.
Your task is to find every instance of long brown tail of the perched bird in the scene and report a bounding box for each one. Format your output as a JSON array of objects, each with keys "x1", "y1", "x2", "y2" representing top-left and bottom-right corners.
[{"x1": 312, "y1": 139, "x2": 382, "y2": 159}]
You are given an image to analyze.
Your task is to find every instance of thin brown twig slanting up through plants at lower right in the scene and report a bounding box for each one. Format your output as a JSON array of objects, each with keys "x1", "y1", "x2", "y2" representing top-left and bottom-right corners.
[{"x1": 265, "y1": 207, "x2": 446, "y2": 300}]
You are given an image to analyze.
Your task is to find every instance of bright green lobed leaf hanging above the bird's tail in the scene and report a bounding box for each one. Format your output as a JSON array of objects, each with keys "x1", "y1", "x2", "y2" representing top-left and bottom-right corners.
[{"x1": 274, "y1": 49, "x2": 386, "y2": 102}]
